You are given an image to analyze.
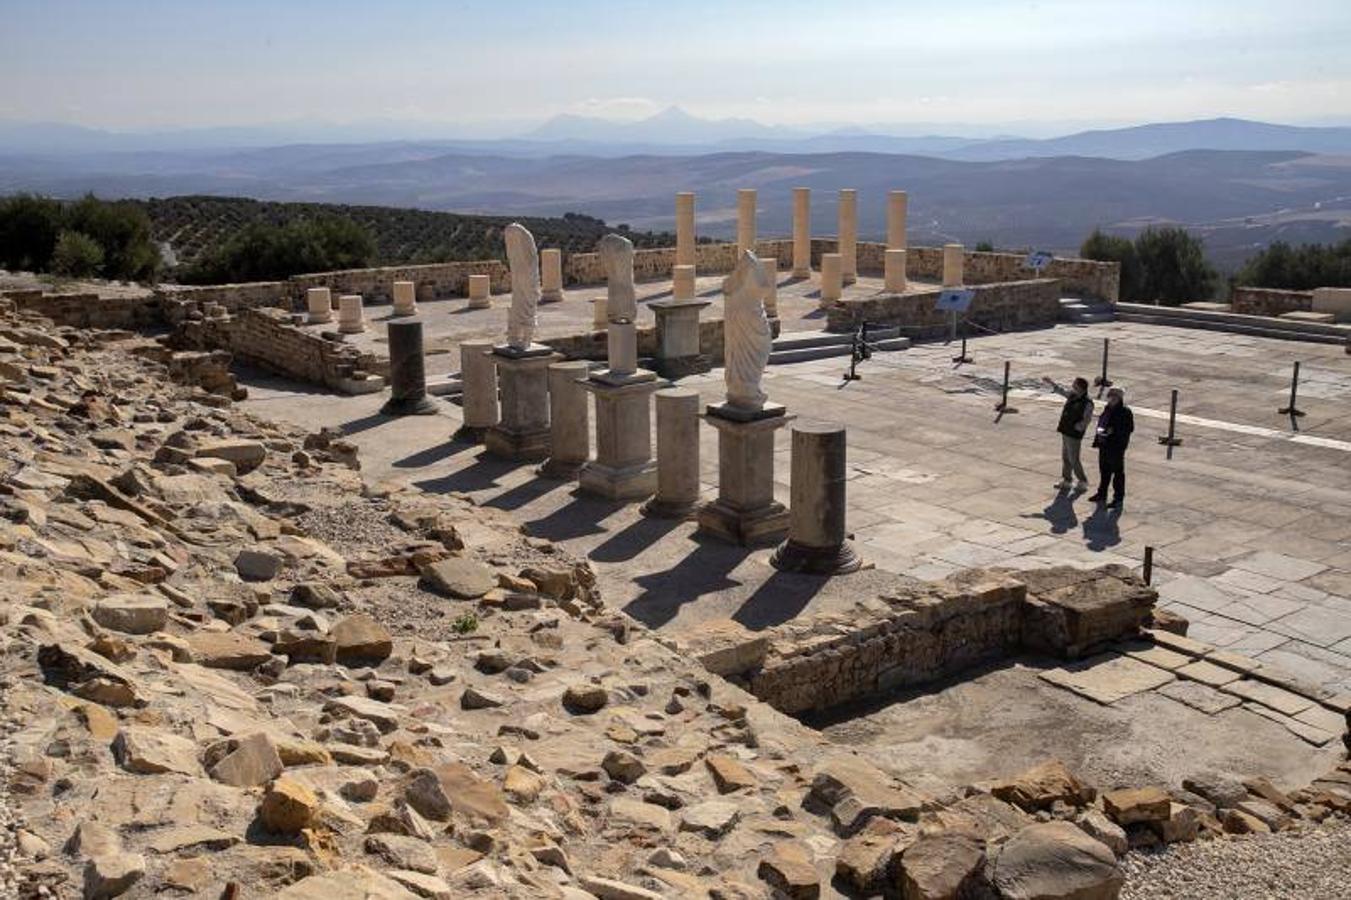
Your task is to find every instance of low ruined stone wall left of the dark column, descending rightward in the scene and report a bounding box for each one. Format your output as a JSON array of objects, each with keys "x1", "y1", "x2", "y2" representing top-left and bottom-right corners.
[{"x1": 170, "y1": 308, "x2": 388, "y2": 393}]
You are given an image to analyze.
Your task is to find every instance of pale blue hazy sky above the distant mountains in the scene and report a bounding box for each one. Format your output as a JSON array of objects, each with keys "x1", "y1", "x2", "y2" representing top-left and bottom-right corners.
[{"x1": 0, "y1": 0, "x2": 1351, "y2": 132}]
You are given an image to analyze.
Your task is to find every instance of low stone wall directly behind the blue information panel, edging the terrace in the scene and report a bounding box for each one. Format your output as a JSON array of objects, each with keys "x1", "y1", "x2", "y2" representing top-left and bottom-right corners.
[{"x1": 825, "y1": 278, "x2": 1061, "y2": 339}]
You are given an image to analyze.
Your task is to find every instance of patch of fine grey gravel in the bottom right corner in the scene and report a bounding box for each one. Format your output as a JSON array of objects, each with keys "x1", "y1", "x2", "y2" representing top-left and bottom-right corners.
[{"x1": 1121, "y1": 819, "x2": 1351, "y2": 900}]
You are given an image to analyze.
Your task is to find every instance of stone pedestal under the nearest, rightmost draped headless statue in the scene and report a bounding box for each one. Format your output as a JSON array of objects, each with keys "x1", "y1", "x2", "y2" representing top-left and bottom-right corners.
[{"x1": 697, "y1": 403, "x2": 793, "y2": 546}]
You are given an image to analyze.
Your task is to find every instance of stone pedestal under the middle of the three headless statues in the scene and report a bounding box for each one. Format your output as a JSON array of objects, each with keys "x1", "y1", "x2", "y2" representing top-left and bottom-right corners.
[{"x1": 577, "y1": 370, "x2": 667, "y2": 500}]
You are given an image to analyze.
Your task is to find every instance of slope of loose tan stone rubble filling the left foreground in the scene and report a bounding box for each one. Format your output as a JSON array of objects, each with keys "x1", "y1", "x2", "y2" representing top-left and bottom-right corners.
[{"x1": 0, "y1": 297, "x2": 1351, "y2": 900}]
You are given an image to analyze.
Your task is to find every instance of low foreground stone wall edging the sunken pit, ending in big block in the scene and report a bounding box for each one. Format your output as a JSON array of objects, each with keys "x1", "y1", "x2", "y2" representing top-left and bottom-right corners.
[{"x1": 680, "y1": 566, "x2": 1156, "y2": 715}]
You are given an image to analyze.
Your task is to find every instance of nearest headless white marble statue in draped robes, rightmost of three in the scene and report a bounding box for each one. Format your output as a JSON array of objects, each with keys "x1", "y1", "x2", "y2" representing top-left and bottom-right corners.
[{"x1": 723, "y1": 250, "x2": 773, "y2": 409}]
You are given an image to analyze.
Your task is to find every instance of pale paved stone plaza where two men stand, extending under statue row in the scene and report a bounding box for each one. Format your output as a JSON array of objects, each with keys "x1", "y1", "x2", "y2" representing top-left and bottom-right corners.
[{"x1": 250, "y1": 280, "x2": 1351, "y2": 691}]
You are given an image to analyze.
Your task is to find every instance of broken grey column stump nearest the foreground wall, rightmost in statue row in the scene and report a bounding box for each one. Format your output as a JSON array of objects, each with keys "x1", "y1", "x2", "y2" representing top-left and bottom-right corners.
[{"x1": 770, "y1": 423, "x2": 862, "y2": 574}]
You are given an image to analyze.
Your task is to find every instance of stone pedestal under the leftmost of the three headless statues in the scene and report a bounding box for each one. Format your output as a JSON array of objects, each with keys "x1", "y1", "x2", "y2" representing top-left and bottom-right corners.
[{"x1": 484, "y1": 343, "x2": 559, "y2": 462}]
